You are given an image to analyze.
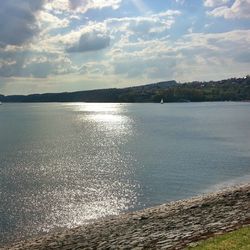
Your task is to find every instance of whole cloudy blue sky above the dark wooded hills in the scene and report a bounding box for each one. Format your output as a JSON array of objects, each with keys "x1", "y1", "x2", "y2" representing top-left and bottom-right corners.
[{"x1": 0, "y1": 0, "x2": 250, "y2": 95}]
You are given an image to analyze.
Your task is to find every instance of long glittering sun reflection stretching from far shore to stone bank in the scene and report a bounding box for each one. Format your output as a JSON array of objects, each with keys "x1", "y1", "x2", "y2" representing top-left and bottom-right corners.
[{"x1": 24, "y1": 103, "x2": 138, "y2": 232}]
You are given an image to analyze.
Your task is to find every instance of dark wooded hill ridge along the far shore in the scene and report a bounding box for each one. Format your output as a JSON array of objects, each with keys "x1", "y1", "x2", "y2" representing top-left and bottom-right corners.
[{"x1": 0, "y1": 76, "x2": 250, "y2": 102}]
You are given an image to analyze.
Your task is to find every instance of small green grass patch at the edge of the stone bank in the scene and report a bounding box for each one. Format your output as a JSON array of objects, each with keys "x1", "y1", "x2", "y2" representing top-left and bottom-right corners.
[{"x1": 188, "y1": 226, "x2": 250, "y2": 250}]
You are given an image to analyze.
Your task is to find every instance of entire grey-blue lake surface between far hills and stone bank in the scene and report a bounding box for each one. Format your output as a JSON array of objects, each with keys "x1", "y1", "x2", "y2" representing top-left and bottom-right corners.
[{"x1": 0, "y1": 102, "x2": 250, "y2": 244}]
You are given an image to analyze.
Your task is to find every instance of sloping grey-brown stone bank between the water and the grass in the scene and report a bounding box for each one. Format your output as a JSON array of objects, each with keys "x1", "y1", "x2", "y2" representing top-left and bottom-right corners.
[{"x1": 0, "y1": 184, "x2": 250, "y2": 250}]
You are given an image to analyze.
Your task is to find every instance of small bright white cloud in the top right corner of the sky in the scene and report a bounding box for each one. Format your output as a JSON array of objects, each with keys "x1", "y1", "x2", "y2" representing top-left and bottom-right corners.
[{"x1": 208, "y1": 0, "x2": 250, "y2": 19}]
